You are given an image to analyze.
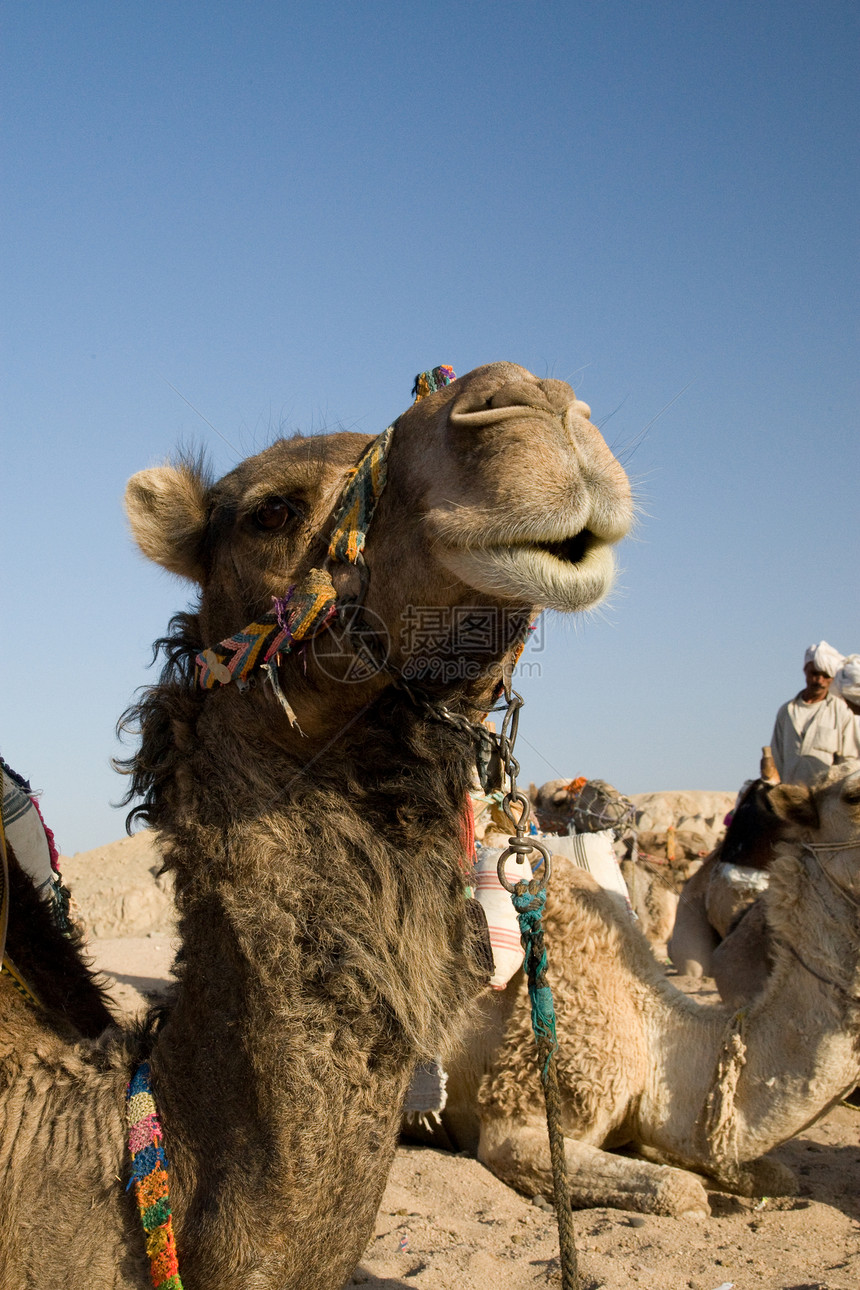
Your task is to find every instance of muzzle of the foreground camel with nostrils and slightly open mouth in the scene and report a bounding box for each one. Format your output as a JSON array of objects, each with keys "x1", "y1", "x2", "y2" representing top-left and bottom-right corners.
[{"x1": 381, "y1": 362, "x2": 632, "y2": 613}]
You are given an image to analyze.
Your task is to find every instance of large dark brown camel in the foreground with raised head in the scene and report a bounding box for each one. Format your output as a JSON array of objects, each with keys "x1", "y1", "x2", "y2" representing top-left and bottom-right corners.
[{"x1": 0, "y1": 362, "x2": 632, "y2": 1290}]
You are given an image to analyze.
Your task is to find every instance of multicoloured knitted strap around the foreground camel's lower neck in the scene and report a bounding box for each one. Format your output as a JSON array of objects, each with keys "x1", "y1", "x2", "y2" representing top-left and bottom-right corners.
[{"x1": 125, "y1": 1062, "x2": 182, "y2": 1290}]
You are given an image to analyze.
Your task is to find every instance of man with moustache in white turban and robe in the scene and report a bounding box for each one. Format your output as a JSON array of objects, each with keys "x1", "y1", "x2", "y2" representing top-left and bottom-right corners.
[{"x1": 771, "y1": 641, "x2": 860, "y2": 784}]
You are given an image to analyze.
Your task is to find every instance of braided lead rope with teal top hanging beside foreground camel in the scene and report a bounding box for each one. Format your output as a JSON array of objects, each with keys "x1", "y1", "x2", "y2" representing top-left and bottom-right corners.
[{"x1": 511, "y1": 878, "x2": 579, "y2": 1290}]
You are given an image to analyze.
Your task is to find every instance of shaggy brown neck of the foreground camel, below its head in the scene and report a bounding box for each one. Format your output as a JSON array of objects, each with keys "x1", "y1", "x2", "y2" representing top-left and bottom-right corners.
[{"x1": 122, "y1": 642, "x2": 484, "y2": 1285}]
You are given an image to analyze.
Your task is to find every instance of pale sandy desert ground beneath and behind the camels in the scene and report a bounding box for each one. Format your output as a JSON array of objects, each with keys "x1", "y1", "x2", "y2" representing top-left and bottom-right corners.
[{"x1": 63, "y1": 815, "x2": 860, "y2": 1290}]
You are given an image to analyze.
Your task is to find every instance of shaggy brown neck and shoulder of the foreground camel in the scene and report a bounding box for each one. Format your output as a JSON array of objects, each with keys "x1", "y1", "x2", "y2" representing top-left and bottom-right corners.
[{"x1": 0, "y1": 624, "x2": 495, "y2": 1290}]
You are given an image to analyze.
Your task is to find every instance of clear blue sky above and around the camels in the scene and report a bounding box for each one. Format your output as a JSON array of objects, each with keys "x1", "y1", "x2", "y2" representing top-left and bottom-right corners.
[{"x1": 0, "y1": 0, "x2": 860, "y2": 853}]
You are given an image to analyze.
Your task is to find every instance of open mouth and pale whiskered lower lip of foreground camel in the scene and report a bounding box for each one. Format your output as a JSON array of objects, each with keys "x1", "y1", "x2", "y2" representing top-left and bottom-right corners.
[{"x1": 442, "y1": 529, "x2": 615, "y2": 613}]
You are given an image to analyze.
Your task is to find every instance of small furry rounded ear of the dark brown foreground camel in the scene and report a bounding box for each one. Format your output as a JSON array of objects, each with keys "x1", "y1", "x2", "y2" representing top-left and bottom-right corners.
[{"x1": 125, "y1": 462, "x2": 208, "y2": 582}]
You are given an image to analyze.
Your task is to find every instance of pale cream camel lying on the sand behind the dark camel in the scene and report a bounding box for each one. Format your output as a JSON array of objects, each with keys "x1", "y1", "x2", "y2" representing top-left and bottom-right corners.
[{"x1": 442, "y1": 773, "x2": 860, "y2": 1216}]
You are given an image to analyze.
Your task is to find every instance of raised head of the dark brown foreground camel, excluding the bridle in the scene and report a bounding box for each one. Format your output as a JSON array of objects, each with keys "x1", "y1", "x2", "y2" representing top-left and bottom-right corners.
[{"x1": 126, "y1": 362, "x2": 632, "y2": 724}]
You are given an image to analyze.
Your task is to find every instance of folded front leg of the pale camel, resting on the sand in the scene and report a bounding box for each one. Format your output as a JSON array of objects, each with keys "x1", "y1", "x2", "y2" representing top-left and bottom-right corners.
[{"x1": 478, "y1": 1117, "x2": 710, "y2": 1218}]
